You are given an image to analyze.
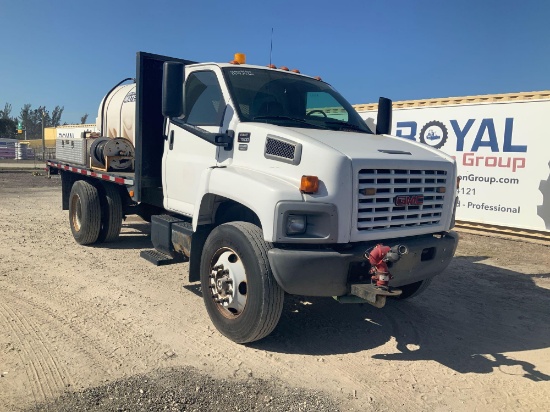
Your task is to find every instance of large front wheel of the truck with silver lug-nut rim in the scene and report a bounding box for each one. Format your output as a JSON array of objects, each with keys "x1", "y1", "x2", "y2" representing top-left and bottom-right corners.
[{"x1": 200, "y1": 222, "x2": 284, "y2": 343}]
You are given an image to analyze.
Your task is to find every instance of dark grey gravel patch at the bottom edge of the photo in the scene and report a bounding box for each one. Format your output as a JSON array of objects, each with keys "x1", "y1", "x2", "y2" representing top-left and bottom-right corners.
[{"x1": 33, "y1": 368, "x2": 340, "y2": 412}]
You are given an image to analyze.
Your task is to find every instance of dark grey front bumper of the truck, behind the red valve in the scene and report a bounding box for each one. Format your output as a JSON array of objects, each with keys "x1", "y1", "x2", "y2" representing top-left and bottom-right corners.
[{"x1": 268, "y1": 231, "x2": 458, "y2": 296}]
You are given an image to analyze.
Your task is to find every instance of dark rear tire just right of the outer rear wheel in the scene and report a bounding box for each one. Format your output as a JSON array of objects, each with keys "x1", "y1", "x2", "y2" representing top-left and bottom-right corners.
[{"x1": 97, "y1": 183, "x2": 122, "y2": 242}]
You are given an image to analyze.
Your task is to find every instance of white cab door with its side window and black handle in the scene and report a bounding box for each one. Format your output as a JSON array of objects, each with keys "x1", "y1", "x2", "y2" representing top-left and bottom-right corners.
[{"x1": 162, "y1": 70, "x2": 225, "y2": 216}]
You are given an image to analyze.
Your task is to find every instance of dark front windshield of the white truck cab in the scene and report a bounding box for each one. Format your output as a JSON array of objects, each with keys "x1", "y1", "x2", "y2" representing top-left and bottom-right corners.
[{"x1": 223, "y1": 67, "x2": 372, "y2": 133}]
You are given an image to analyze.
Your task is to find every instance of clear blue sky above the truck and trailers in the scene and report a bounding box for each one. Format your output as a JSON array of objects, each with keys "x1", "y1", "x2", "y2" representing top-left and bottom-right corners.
[{"x1": 0, "y1": 0, "x2": 550, "y2": 123}]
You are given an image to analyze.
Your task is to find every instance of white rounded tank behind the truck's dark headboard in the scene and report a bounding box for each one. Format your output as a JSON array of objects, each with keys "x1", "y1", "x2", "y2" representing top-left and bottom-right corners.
[{"x1": 96, "y1": 83, "x2": 136, "y2": 144}]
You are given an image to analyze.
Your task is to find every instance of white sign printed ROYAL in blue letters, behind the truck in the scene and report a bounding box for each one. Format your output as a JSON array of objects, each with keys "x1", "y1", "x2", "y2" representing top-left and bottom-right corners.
[{"x1": 359, "y1": 100, "x2": 550, "y2": 231}]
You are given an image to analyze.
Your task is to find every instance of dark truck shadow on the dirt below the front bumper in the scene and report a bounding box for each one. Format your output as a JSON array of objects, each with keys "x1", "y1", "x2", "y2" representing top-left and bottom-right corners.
[{"x1": 251, "y1": 257, "x2": 550, "y2": 381}]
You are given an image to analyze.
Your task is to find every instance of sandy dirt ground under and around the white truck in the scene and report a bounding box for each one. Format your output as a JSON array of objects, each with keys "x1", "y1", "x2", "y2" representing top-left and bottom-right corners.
[{"x1": 0, "y1": 173, "x2": 550, "y2": 411}]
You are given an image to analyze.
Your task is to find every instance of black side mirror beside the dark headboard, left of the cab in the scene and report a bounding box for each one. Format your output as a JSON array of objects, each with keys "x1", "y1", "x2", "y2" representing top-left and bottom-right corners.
[{"x1": 162, "y1": 62, "x2": 185, "y2": 118}]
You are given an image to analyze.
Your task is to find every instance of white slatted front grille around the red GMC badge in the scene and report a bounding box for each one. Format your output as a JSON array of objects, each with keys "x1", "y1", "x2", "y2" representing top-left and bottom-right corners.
[{"x1": 357, "y1": 169, "x2": 447, "y2": 231}]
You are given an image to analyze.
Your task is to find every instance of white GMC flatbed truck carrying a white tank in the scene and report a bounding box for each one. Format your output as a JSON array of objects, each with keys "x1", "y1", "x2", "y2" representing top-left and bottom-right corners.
[{"x1": 47, "y1": 52, "x2": 458, "y2": 343}]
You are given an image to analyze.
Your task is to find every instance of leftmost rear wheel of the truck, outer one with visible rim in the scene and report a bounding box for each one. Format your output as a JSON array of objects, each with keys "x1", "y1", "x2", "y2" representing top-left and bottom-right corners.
[{"x1": 69, "y1": 180, "x2": 101, "y2": 245}]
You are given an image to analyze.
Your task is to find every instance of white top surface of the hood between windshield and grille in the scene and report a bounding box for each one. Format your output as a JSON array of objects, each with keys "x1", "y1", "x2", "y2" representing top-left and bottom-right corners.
[{"x1": 290, "y1": 128, "x2": 454, "y2": 162}]
